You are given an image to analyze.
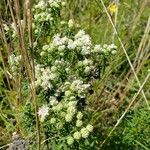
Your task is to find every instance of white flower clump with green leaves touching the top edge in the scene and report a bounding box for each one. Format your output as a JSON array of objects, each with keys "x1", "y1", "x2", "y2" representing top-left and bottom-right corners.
[{"x1": 32, "y1": 0, "x2": 65, "y2": 39}]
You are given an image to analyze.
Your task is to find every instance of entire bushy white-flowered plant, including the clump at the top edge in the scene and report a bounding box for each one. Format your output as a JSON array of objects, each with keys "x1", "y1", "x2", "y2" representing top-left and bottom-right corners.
[{"x1": 5, "y1": 0, "x2": 116, "y2": 149}]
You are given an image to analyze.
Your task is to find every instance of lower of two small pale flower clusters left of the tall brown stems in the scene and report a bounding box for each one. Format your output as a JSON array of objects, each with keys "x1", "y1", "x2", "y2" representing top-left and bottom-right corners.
[{"x1": 8, "y1": 54, "x2": 21, "y2": 76}]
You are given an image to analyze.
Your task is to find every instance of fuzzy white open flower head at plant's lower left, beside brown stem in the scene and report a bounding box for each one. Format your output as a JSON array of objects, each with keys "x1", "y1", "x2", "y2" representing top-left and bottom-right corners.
[{"x1": 38, "y1": 105, "x2": 49, "y2": 122}]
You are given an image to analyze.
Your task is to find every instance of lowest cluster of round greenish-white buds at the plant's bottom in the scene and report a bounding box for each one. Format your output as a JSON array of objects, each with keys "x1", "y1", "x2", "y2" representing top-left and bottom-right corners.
[{"x1": 44, "y1": 97, "x2": 93, "y2": 145}]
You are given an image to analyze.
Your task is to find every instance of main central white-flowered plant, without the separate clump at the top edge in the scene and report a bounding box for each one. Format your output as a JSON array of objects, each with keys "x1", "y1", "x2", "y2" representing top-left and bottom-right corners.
[{"x1": 35, "y1": 30, "x2": 116, "y2": 148}]
